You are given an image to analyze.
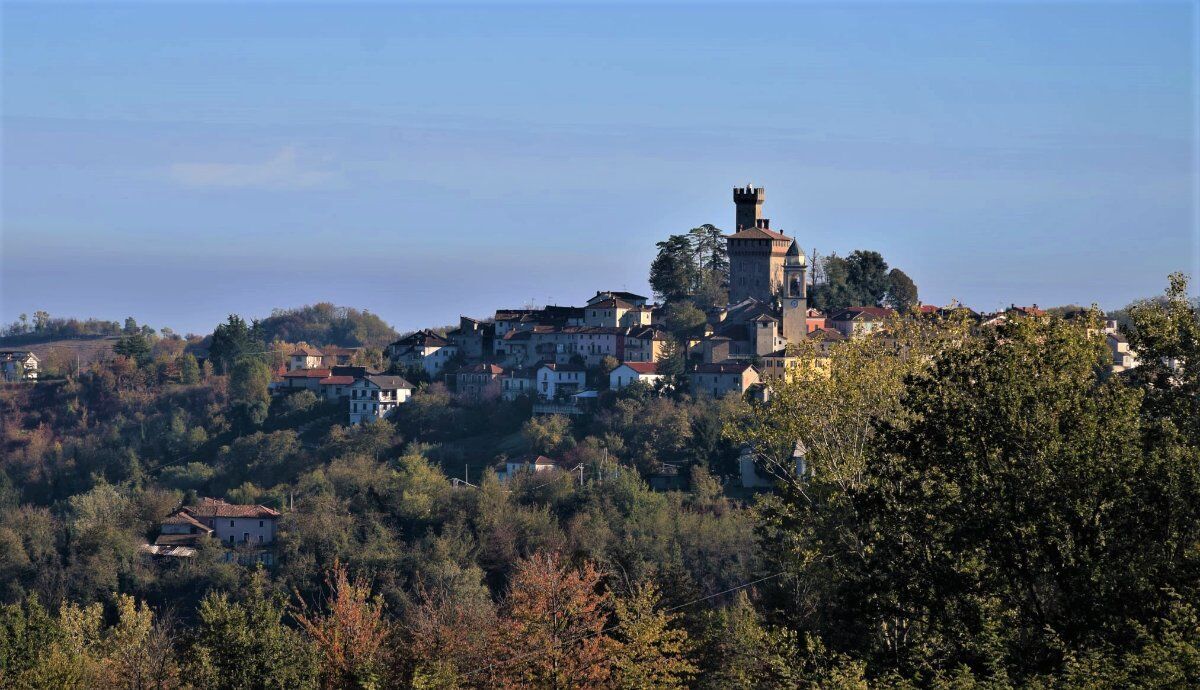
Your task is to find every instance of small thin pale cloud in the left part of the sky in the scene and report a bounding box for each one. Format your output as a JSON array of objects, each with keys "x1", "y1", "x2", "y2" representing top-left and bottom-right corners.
[{"x1": 170, "y1": 146, "x2": 338, "y2": 190}]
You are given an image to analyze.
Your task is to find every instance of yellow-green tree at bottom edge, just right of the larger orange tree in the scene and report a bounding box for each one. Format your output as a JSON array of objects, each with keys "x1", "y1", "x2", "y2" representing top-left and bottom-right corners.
[{"x1": 613, "y1": 582, "x2": 697, "y2": 690}]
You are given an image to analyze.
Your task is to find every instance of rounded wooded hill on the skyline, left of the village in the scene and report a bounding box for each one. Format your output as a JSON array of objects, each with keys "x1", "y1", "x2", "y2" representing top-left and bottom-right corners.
[{"x1": 260, "y1": 302, "x2": 397, "y2": 348}]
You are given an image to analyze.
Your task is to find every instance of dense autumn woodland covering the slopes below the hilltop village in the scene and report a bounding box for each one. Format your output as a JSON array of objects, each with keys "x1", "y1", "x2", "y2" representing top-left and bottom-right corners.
[{"x1": 0, "y1": 276, "x2": 1200, "y2": 688}]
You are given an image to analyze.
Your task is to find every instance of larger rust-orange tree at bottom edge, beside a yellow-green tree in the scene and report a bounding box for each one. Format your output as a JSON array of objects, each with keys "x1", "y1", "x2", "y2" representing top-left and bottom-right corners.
[{"x1": 491, "y1": 553, "x2": 614, "y2": 688}]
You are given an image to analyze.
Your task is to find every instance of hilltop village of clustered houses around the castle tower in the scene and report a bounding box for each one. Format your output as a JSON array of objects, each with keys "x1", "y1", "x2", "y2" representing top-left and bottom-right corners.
[{"x1": 274, "y1": 185, "x2": 1136, "y2": 424}]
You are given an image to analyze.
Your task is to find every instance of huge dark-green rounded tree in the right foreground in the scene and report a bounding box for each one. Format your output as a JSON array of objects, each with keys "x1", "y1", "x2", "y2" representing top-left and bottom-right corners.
[{"x1": 826, "y1": 319, "x2": 1200, "y2": 680}]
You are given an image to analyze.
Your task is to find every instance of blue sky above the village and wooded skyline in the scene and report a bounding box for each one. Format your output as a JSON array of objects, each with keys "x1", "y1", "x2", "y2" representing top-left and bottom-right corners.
[{"x1": 0, "y1": 2, "x2": 1200, "y2": 334}]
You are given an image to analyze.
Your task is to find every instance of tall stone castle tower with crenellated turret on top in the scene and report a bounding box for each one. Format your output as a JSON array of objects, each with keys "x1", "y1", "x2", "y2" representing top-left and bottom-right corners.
[{"x1": 725, "y1": 186, "x2": 792, "y2": 305}]
